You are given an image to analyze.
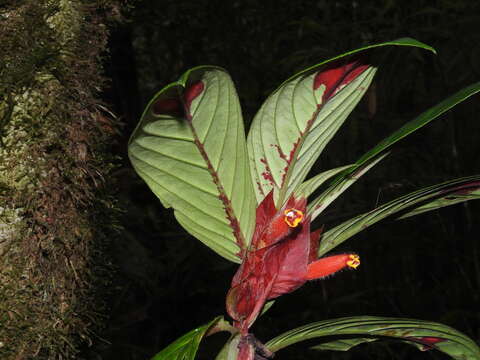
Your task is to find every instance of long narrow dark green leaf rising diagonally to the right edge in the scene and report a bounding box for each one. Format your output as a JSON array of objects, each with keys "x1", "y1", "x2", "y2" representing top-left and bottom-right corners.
[{"x1": 309, "y1": 82, "x2": 480, "y2": 224}]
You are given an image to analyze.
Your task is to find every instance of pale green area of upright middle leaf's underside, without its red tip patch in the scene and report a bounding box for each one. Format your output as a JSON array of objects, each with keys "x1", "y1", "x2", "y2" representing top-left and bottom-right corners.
[{"x1": 247, "y1": 63, "x2": 375, "y2": 207}]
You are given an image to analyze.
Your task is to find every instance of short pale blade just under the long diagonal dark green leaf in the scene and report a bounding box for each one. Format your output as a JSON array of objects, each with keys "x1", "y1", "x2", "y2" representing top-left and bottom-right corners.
[{"x1": 307, "y1": 152, "x2": 389, "y2": 220}]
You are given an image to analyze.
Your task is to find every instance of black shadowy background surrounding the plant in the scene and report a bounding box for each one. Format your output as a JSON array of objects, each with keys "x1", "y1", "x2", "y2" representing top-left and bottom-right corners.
[{"x1": 88, "y1": 0, "x2": 480, "y2": 360}]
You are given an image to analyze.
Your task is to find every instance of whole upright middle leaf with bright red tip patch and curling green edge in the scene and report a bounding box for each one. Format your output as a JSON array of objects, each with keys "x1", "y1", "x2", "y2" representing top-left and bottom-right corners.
[{"x1": 247, "y1": 38, "x2": 433, "y2": 204}]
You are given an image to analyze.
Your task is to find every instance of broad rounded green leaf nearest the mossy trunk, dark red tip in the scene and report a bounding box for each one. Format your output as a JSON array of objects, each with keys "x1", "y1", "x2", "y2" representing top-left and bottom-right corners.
[{"x1": 128, "y1": 66, "x2": 256, "y2": 262}]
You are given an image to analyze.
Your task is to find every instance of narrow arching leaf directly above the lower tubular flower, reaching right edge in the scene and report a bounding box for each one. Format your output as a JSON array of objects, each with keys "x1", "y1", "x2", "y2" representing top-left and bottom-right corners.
[{"x1": 318, "y1": 175, "x2": 480, "y2": 256}]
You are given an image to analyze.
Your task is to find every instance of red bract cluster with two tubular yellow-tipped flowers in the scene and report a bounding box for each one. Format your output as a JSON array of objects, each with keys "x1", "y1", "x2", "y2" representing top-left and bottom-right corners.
[{"x1": 227, "y1": 192, "x2": 360, "y2": 335}]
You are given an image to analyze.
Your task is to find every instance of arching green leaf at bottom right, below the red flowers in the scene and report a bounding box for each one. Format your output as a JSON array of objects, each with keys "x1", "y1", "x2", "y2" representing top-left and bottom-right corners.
[{"x1": 266, "y1": 316, "x2": 480, "y2": 360}]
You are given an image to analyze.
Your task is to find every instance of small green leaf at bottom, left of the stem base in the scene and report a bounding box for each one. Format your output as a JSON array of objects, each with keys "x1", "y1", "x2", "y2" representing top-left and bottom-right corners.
[{"x1": 151, "y1": 316, "x2": 223, "y2": 360}]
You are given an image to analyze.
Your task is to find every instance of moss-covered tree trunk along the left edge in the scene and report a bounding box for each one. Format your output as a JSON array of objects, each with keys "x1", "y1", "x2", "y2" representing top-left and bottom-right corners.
[{"x1": 0, "y1": 0, "x2": 123, "y2": 359}]
